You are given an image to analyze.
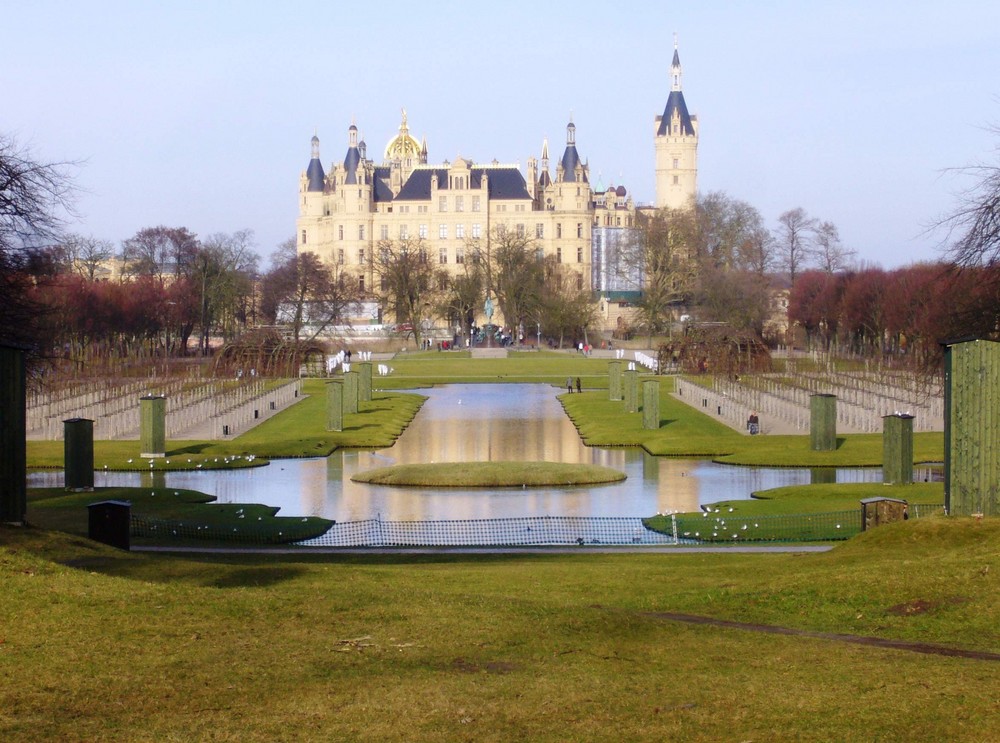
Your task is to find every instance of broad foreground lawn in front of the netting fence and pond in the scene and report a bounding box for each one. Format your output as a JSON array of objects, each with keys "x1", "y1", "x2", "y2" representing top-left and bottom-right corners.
[{"x1": 0, "y1": 518, "x2": 1000, "y2": 743}]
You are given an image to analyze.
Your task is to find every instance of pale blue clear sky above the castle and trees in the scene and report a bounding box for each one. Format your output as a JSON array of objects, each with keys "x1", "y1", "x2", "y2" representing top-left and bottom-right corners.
[{"x1": 0, "y1": 0, "x2": 1000, "y2": 268}]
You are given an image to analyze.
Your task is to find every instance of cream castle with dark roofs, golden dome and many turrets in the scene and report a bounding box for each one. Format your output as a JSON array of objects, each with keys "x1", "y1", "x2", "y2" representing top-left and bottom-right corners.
[{"x1": 296, "y1": 41, "x2": 698, "y2": 332}]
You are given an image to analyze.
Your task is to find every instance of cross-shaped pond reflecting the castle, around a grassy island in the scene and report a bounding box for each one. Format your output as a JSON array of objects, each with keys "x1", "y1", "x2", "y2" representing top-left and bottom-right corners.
[{"x1": 29, "y1": 384, "x2": 882, "y2": 521}]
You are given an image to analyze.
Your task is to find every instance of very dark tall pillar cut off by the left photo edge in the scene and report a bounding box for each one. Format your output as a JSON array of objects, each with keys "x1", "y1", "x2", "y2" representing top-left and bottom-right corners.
[{"x1": 0, "y1": 345, "x2": 28, "y2": 524}]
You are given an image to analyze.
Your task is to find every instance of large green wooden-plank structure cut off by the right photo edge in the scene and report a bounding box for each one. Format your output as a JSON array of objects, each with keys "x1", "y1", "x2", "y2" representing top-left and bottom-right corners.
[{"x1": 944, "y1": 339, "x2": 1000, "y2": 516}]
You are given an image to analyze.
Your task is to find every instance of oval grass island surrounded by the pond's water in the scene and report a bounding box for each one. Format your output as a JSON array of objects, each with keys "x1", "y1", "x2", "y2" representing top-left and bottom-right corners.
[{"x1": 351, "y1": 462, "x2": 625, "y2": 488}]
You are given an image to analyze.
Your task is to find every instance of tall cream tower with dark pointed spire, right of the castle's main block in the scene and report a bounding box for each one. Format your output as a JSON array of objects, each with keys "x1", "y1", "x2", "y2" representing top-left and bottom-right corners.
[{"x1": 653, "y1": 35, "x2": 698, "y2": 209}]
